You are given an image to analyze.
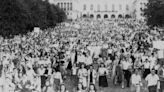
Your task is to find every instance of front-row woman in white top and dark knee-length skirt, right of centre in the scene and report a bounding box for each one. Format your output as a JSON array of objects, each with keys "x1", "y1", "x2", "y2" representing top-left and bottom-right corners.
[{"x1": 98, "y1": 64, "x2": 108, "y2": 89}]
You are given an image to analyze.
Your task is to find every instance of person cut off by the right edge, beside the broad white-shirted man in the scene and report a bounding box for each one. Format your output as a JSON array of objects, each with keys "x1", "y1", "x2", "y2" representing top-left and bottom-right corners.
[{"x1": 158, "y1": 64, "x2": 164, "y2": 92}]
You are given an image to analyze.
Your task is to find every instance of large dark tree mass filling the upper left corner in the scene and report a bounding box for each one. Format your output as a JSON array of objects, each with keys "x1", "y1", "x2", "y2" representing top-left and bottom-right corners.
[{"x1": 0, "y1": 0, "x2": 66, "y2": 37}]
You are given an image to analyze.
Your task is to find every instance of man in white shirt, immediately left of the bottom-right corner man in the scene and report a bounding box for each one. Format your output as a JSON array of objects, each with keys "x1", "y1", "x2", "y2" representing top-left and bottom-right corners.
[{"x1": 131, "y1": 69, "x2": 141, "y2": 92}]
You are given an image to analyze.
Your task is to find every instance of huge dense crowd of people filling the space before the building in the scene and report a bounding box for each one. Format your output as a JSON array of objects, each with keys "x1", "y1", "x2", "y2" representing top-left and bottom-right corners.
[{"x1": 0, "y1": 19, "x2": 164, "y2": 92}]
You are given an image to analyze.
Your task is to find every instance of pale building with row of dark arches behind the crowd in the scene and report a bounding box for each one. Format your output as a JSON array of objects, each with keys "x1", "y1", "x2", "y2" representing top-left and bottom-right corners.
[{"x1": 49, "y1": 0, "x2": 147, "y2": 19}]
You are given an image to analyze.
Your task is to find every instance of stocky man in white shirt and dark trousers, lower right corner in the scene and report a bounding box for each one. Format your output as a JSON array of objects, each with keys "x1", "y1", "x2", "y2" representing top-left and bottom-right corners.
[{"x1": 145, "y1": 69, "x2": 159, "y2": 92}]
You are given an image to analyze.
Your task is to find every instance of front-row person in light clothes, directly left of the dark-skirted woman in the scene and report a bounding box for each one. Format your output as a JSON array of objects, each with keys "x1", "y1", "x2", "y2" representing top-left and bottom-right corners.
[{"x1": 88, "y1": 65, "x2": 97, "y2": 86}]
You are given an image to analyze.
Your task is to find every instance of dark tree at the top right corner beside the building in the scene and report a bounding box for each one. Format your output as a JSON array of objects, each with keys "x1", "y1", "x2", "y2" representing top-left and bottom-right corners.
[{"x1": 144, "y1": 0, "x2": 164, "y2": 27}]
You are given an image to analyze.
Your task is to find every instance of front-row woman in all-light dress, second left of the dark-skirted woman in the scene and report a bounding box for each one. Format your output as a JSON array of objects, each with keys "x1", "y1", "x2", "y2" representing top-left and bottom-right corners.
[{"x1": 77, "y1": 64, "x2": 87, "y2": 88}]
